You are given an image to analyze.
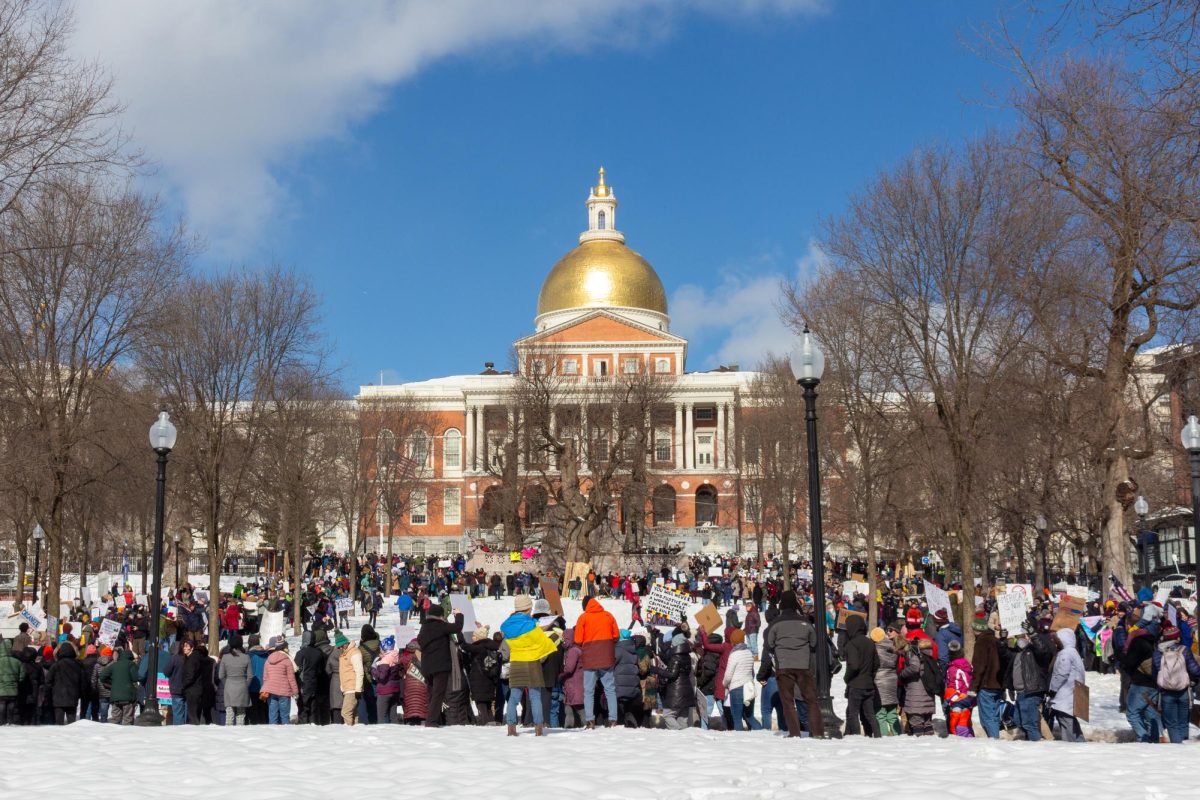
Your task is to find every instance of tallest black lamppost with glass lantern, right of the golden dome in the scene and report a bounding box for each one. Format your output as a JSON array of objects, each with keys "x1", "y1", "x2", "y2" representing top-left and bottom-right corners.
[{"x1": 791, "y1": 326, "x2": 841, "y2": 738}]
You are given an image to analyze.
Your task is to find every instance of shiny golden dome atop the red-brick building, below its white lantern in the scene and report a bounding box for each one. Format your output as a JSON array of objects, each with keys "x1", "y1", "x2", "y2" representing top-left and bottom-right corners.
[{"x1": 538, "y1": 239, "x2": 667, "y2": 315}]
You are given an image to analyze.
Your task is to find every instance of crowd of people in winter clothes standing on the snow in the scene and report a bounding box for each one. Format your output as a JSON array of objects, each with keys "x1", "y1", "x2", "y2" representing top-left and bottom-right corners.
[{"x1": 0, "y1": 554, "x2": 1200, "y2": 742}]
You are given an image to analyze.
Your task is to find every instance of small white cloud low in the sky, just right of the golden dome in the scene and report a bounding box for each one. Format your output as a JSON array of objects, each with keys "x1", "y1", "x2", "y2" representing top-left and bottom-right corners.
[{"x1": 670, "y1": 241, "x2": 828, "y2": 369}]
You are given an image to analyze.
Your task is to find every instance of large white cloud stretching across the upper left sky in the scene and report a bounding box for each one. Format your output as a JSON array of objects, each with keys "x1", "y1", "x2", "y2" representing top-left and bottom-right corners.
[{"x1": 63, "y1": 0, "x2": 826, "y2": 251}]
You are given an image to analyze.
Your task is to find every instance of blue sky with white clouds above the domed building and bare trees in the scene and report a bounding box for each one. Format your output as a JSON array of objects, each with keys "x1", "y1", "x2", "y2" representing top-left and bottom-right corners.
[{"x1": 65, "y1": 0, "x2": 1060, "y2": 389}]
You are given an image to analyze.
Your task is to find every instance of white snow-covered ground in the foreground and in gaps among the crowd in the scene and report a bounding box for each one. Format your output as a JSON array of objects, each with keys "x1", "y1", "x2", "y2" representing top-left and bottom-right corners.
[{"x1": 0, "y1": 587, "x2": 1200, "y2": 800}]
